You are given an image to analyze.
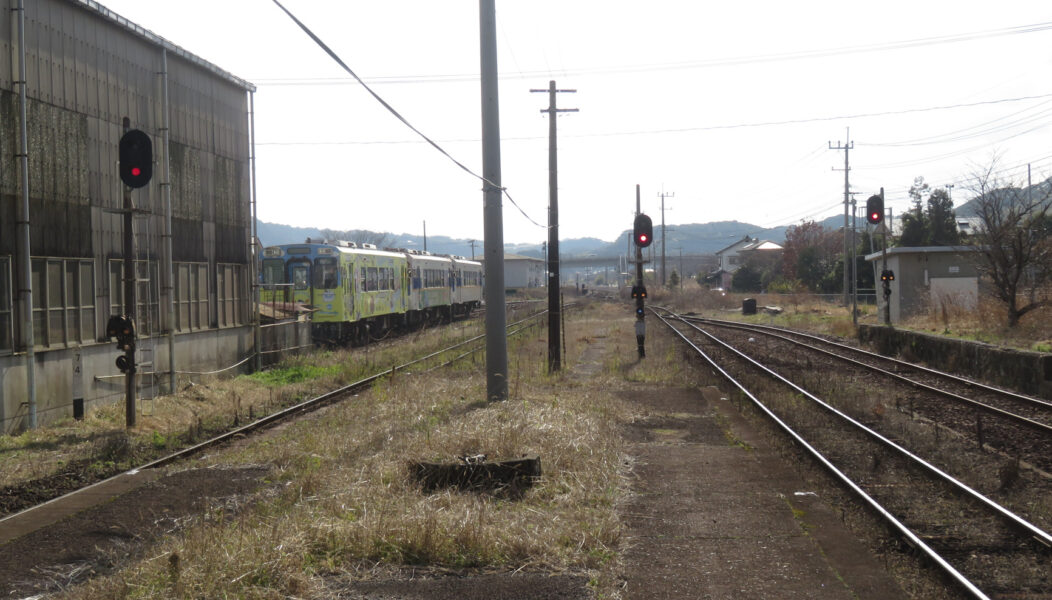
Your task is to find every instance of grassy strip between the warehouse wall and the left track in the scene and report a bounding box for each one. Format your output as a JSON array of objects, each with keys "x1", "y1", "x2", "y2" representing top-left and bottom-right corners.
[{"x1": 0, "y1": 321, "x2": 496, "y2": 486}]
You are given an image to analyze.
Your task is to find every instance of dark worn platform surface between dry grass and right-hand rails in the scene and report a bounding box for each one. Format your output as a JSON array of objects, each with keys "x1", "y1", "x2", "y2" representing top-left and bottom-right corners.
[{"x1": 625, "y1": 388, "x2": 906, "y2": 600}]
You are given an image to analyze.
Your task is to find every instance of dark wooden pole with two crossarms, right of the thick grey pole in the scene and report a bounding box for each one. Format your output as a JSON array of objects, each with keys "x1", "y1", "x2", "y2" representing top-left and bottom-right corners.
[{"x1": 530, "y1": 80, "x2": 578, "y2": 373}]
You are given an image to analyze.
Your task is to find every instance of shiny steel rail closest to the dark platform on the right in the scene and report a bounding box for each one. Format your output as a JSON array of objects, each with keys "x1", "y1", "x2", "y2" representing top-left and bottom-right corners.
[{"x1": 651, "y1": 308, "x2": 990, "y2": 600}]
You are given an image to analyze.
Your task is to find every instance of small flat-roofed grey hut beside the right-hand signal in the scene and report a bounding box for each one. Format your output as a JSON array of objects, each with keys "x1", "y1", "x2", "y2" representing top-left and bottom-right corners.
[{"x1": 866, "y1": 246, "x2": 979, "y2": 323}]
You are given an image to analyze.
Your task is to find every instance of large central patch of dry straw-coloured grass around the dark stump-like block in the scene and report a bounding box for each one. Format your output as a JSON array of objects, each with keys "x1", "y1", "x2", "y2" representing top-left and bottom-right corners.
[{"x1": 47, "y1": 304, "x2": 679, "y2": 598}]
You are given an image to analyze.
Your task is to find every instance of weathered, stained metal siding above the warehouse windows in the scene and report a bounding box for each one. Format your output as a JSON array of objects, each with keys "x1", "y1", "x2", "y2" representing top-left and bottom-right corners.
[{"x1": 0, "y1": 0, "x2": 250, "y2": 338}]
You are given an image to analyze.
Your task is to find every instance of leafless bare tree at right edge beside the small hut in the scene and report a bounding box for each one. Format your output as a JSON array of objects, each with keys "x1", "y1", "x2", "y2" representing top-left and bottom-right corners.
[{"x1": 968, "y1": 161, "x2": 1052, "y2": 327}]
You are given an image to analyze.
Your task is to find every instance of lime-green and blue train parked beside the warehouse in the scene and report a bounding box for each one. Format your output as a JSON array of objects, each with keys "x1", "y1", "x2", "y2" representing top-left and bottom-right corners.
[{"x1": 260, "y1": 238, "x2": 483, "y2": 345}]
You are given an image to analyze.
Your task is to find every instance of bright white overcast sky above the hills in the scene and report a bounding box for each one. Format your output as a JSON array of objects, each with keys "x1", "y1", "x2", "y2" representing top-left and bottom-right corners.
[{"x1": 103, "y1": 0, "x2": 1052, "y2": 243}]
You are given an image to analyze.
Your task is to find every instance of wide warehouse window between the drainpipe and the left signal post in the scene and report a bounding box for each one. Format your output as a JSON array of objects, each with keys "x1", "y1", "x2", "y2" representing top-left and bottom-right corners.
[{"x1": 30, "y1": 258, "x2": 96, "y2": 347}]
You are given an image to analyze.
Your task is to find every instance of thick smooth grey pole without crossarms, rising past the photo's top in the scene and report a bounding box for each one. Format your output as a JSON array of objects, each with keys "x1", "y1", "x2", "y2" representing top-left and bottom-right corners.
[{"x1": 479, "y1": 0, "x2": 508, "y2": 402}]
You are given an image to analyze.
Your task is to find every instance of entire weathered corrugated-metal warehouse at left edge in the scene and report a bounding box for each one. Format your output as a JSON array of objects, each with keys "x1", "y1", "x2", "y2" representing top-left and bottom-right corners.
[{"x1": 0, "y1": 0, "x2": 255, "y2": 433}]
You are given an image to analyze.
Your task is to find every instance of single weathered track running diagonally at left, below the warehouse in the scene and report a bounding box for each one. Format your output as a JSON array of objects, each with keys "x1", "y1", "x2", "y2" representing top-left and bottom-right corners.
[{"x1": 0, "y1": 311, "x2": 547, "y2": 536}]
